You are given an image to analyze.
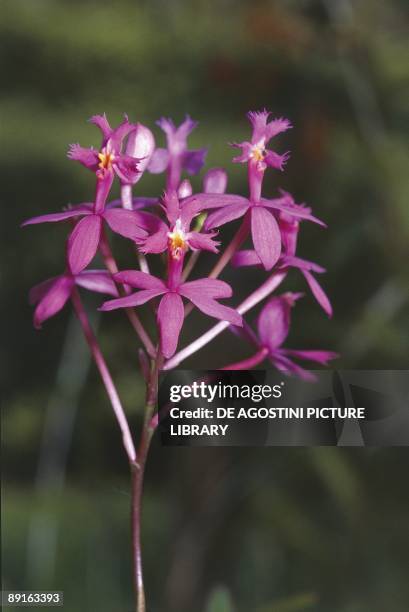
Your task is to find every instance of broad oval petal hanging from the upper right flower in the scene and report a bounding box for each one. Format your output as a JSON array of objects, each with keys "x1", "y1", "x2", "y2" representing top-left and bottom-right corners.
[{"x1": 251, "y1": 206, "x2": 281, "y2": 270}]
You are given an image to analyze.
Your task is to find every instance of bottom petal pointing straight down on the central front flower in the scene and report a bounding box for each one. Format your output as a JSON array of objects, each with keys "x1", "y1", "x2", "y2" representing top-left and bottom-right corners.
[{"x1": 158, "y1": 293, "x2": 185, "y2": 359}]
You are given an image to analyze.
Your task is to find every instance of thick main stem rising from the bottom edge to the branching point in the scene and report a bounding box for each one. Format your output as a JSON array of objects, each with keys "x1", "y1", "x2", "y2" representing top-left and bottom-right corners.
[{"x1": 131, "y1": 352, "x2": 163, "y2": 612}]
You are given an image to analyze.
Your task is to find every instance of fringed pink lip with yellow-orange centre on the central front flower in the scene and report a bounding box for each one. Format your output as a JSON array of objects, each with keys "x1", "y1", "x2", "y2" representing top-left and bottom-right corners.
[{"x1": 137, "y1": 191, "x2": 219, "y2": 260}]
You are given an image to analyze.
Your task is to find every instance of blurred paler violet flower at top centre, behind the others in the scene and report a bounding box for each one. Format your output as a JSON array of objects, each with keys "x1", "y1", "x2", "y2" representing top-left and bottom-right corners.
[{"x1": 148, "y1": 115, "x2": 207, "y2": 190}]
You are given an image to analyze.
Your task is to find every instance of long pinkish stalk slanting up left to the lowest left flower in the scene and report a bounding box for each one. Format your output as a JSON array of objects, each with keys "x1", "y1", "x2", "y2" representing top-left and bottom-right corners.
[{"x1": 71, "y1": 288, "x2": 136, "y2": 465}]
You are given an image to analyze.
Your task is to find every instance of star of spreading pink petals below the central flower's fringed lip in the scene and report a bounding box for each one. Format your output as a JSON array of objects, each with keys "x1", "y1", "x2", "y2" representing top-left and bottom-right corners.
[{"x1": 100, "y1": 270, "x2": 242, "y2": 358}]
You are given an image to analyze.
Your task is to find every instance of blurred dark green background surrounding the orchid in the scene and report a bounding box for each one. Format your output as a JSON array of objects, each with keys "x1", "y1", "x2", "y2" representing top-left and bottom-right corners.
[{"x1": 0, "y1": 0, "x2": 409, "y2": 612}]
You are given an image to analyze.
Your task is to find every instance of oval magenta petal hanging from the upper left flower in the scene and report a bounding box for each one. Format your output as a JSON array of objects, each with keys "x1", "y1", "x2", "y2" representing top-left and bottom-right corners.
[{"x1": 67, "y1": 215, "x2": 102, "y2": 274}]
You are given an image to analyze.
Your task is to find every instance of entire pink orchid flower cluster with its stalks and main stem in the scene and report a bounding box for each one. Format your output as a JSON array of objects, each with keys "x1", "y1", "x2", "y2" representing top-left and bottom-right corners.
[{"x1": 24, "y1": 110, "x2": 336, "y2": 610}]
